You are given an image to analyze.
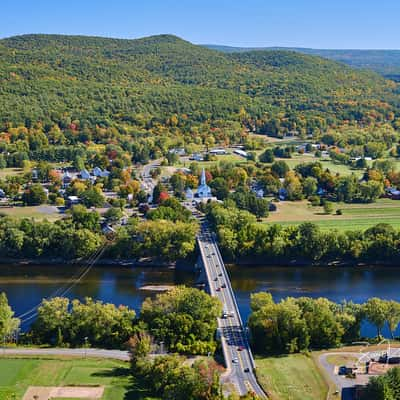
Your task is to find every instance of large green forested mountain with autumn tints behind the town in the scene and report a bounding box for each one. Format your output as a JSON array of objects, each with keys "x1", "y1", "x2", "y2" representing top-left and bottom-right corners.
[{"x1": 0, "y1": 35, "x2": 400, "y2": 137}]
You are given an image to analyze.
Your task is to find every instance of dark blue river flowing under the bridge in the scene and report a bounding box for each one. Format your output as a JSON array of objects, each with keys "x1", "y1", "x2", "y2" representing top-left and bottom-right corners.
[{"x1": 0, "y1": 265, "x2": 400, "y2": 336}]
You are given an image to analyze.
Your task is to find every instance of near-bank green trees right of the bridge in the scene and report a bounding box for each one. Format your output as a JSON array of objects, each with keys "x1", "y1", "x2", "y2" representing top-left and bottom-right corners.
[{"x1": 249, "y1": 292, "x2": 400, "y2": 353}]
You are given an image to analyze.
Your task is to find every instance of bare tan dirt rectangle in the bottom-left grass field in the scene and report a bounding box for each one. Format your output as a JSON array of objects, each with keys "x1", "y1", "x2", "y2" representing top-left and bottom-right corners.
[{"x1": 22, "y1": 386, "x2": 104, "y2": 400}]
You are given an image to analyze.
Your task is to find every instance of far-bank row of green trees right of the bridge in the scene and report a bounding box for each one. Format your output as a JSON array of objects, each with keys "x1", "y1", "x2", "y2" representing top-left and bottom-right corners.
[{"x1": 206, "y1": 202, "x2": 400, "y2": 263}]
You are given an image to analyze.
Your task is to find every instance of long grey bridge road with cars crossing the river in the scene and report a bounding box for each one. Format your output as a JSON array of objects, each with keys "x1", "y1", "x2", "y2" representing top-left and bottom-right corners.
[{"x1": 192, "y1": 210, "x2": 266, "y2": 398}]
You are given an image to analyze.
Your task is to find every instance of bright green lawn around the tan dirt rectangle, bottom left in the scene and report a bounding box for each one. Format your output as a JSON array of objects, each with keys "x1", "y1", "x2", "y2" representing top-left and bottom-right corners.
[{"x1": 0, "y1": 357, "x2": 134, "y2": 400}]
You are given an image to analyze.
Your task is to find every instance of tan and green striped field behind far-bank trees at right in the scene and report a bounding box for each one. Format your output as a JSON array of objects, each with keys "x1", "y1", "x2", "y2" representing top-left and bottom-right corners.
[{"x1": 264, "y1": 199, "x2": 400, "y2": 231}]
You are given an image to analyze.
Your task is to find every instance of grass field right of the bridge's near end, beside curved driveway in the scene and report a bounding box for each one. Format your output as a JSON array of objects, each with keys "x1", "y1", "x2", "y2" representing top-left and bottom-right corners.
[{"x1": 256, "y1": 354, "x2": 328, "y2": 400}]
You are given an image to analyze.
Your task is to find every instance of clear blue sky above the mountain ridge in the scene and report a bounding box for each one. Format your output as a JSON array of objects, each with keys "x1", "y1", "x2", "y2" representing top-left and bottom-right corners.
[{"x1": 0, "y1": 0, "x2": 400, "y2": 49}]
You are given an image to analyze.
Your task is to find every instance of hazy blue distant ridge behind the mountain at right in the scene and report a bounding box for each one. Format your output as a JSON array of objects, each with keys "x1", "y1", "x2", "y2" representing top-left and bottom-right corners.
[{"x1": 204, "y1": 44, "x2": 400, "y2": 81}]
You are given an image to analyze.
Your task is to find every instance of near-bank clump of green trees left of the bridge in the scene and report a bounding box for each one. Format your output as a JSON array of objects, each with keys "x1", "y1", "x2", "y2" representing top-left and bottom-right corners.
[{"x1": 28, "y1": 287, "x2": 222, "y2": 358}]
